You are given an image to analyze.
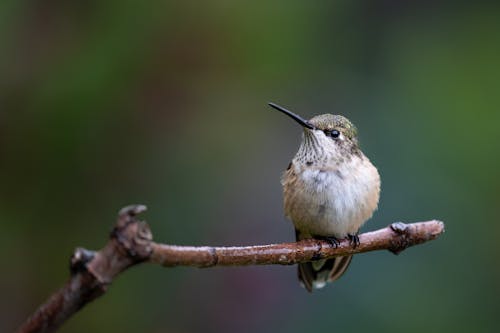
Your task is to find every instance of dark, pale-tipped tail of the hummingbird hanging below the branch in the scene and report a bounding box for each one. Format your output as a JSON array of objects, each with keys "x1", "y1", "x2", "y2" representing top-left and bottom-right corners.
[{"x1": 297, "y1": 231, "x2": 352, "y2": 292}]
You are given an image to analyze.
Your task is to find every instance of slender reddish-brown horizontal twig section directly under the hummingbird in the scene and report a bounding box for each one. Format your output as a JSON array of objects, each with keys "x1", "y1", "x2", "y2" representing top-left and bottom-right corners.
[{"x1": 149, "y1": 220, "x2": 444, "y2": 267}]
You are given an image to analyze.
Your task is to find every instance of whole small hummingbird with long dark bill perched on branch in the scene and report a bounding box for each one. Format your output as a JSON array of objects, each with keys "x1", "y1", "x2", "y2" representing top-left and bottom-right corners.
[{"x1": 269, "y1": 103, "x2": 380, "y2": 292}]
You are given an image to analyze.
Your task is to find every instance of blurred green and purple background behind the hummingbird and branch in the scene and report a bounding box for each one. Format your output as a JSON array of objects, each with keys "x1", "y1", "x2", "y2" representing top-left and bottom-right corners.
[{"x1": 0, "y1": 0, "x2": 500, "y2": 333}]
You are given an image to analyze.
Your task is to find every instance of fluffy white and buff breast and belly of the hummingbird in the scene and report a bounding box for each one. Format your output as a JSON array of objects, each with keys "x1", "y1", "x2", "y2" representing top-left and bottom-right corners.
[{"x1": 282, "y1": 155, "x2": 380, "y2": 238}]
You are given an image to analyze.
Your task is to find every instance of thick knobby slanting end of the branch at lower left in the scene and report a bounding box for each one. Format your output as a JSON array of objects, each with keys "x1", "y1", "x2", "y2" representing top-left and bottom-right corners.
[{"x1": 18, "y1": 205, "x2": 152, "y2": 332}]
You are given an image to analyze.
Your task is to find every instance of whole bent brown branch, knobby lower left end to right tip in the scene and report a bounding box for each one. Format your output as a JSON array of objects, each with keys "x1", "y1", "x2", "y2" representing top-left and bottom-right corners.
[{"x1": 18, "y1": 205, "x2": 444, "y2": 333}]
